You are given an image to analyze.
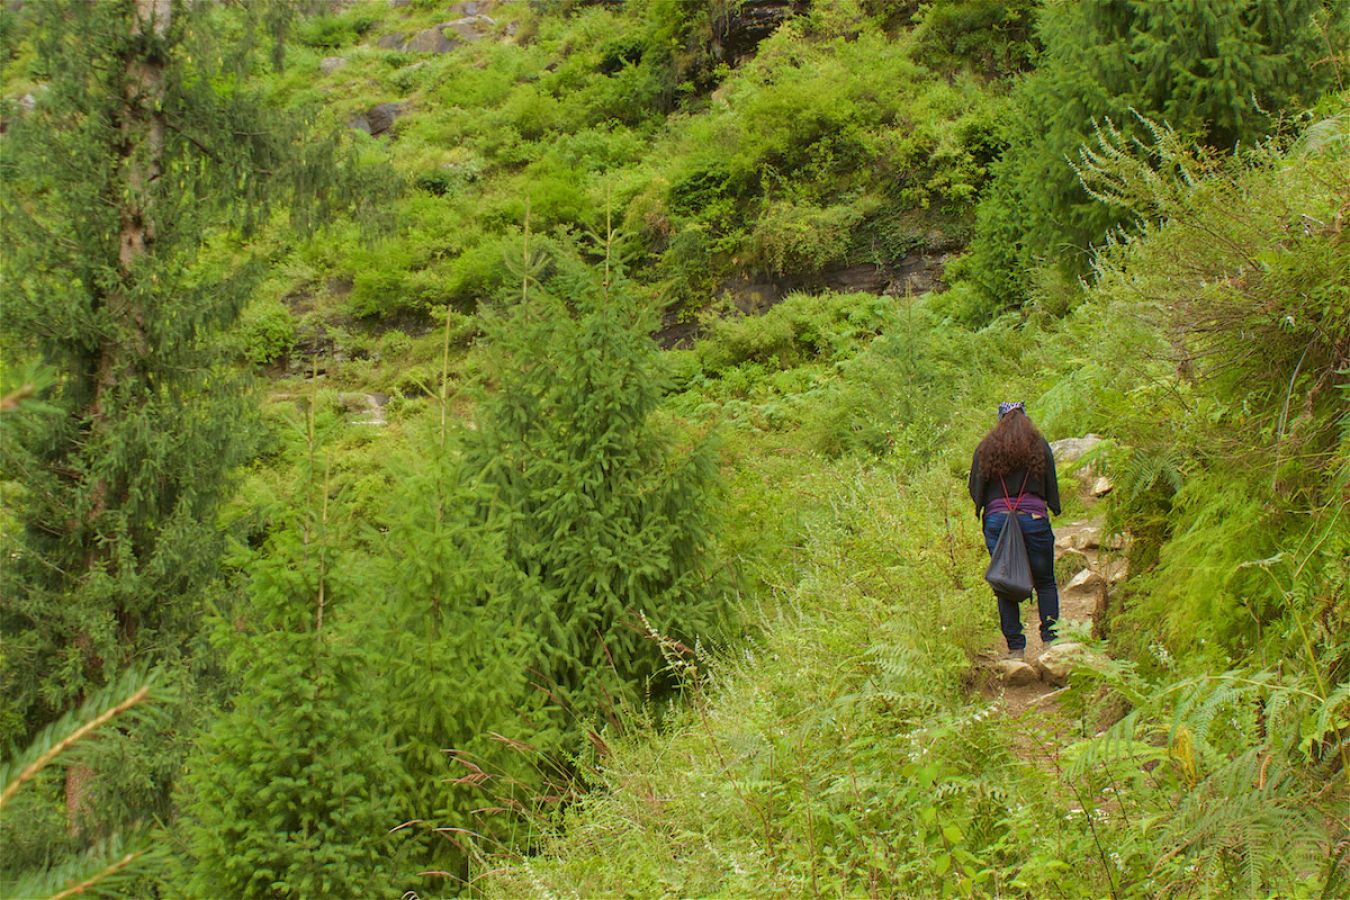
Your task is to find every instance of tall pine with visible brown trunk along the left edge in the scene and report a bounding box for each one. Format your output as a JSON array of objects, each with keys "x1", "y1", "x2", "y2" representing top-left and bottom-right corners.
[{"x1": 0, "y1": 0, "x2": 367, "y2": 831}]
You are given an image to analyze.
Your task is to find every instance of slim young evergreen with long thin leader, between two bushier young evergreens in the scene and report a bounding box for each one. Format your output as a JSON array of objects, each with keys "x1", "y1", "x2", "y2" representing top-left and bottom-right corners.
[{"x1": 371, "y1": 317, "x2": 549, "y2": 889}]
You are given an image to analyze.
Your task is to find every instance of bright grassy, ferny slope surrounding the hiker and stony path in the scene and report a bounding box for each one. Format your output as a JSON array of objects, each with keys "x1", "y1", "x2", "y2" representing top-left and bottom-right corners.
[{"x1": 491, "y1": 116, "x2": 1350, "y2": 896}]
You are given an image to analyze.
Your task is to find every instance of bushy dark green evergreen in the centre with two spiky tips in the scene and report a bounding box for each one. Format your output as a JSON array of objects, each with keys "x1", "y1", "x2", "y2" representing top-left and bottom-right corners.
[{"x1": 464, "y1": 225, "x2": 720, "y2": 734}]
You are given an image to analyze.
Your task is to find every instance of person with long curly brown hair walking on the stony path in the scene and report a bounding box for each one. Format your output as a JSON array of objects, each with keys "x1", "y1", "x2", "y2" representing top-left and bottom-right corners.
[{"x1": 969, "y1": 402, "x2": 1060, "y2": 660}]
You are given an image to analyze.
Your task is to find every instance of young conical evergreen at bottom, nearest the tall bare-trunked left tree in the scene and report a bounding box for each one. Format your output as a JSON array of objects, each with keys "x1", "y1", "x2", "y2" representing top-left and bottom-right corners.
[{"x1": 181, "y1": 414, "x2": 405, "y2": 897}]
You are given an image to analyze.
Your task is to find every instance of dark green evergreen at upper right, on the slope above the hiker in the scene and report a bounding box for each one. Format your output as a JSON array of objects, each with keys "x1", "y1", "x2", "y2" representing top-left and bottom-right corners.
[{"x1": 953, "y1": 0, "x2": 1347, "y2": 314}]
